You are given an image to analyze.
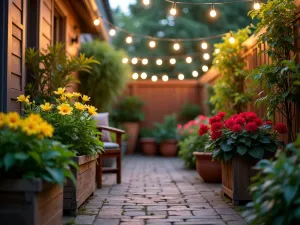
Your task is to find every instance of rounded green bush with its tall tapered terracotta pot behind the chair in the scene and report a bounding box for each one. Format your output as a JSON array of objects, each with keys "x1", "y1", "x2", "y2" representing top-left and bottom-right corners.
[{"x1": 113, "y1": 96, "x2": 144, "y2": 154}]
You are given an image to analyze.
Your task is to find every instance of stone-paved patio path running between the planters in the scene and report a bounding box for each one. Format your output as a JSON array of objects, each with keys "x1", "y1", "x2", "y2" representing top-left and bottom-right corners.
[{"x1": 64, "y1": 156, "x2": 244, "y2": 225}]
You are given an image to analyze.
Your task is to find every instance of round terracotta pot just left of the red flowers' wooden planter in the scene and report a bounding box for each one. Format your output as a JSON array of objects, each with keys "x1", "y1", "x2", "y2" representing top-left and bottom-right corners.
[{"x1": 193, "y1": 152, "x2": 222, "y2": 183}]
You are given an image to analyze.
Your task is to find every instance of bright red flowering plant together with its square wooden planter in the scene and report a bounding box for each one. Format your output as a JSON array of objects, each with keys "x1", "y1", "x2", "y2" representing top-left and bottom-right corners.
[{"x1": 199, "y1": 112, "x2": 287, "y2": 204}]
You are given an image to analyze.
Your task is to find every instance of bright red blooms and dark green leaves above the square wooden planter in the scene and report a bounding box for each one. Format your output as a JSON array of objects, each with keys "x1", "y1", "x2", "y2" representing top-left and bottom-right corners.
[{"x1": 198, "y1": 112, "x2": 287, "y2": 161}]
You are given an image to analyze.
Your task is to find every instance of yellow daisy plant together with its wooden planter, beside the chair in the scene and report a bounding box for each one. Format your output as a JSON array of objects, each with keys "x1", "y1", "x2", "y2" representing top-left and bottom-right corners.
[{"x1": 24, "y1": 88, "x2": 103, "y2": 214}]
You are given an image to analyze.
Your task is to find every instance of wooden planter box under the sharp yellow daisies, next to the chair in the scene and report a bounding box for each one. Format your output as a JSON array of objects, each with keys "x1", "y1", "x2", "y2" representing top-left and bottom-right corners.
[{"x1": 64, "y1": 155, "x2": 96, "y2": 215}]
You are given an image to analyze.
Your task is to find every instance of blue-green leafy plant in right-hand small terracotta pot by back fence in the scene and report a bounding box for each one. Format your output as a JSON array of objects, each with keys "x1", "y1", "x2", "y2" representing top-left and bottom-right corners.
[{"x1": 154, "y1": 114, "x2": 177, "y2": 143}]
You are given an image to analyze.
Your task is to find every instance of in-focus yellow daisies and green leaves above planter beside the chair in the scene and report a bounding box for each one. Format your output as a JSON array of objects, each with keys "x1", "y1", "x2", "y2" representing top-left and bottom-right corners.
[{"x1": 18, "y1": 88, "x2": 103, "y2": 156}]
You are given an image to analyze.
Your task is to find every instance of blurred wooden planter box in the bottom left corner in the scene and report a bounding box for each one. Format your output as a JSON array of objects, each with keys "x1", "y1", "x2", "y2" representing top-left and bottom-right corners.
[{"x1": 0, "y1": 179, "x2": 63, "y2": 225}]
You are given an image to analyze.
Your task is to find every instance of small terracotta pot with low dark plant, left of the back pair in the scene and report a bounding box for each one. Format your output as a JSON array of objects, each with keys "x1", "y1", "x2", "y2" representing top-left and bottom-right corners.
[{"x1": 140, "y1": 129, "x2": 157, "y2": 156}]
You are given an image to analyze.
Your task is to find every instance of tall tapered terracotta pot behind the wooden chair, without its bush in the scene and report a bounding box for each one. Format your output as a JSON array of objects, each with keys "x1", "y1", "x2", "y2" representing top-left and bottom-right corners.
[{"x1": 122, "y1": 123, "x2": 140, "y2": 155}]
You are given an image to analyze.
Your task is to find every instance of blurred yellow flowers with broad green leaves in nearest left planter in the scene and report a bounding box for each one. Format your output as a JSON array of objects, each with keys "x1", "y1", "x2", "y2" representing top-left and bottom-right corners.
[{"x1": 0, "y1": 112, "x2": 77, "y2": 185}]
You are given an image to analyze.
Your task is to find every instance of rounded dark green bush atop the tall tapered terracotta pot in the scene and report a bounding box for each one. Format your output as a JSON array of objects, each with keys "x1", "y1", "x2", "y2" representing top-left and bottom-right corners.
[{"x1": 112, "y1": 96, "x2": 144, "y2": 123}]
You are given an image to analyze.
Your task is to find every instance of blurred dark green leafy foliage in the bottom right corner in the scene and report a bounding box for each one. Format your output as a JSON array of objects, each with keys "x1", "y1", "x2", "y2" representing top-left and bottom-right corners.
[{"x1": 244, "y1": 136, "x2": 300, "y2": 225}]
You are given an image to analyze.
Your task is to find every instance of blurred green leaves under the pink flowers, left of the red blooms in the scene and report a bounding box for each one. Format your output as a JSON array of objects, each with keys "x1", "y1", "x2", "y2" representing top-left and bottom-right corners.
[{"x1": 179, "y1": 134, "x2": 208, "y2": 169}]
